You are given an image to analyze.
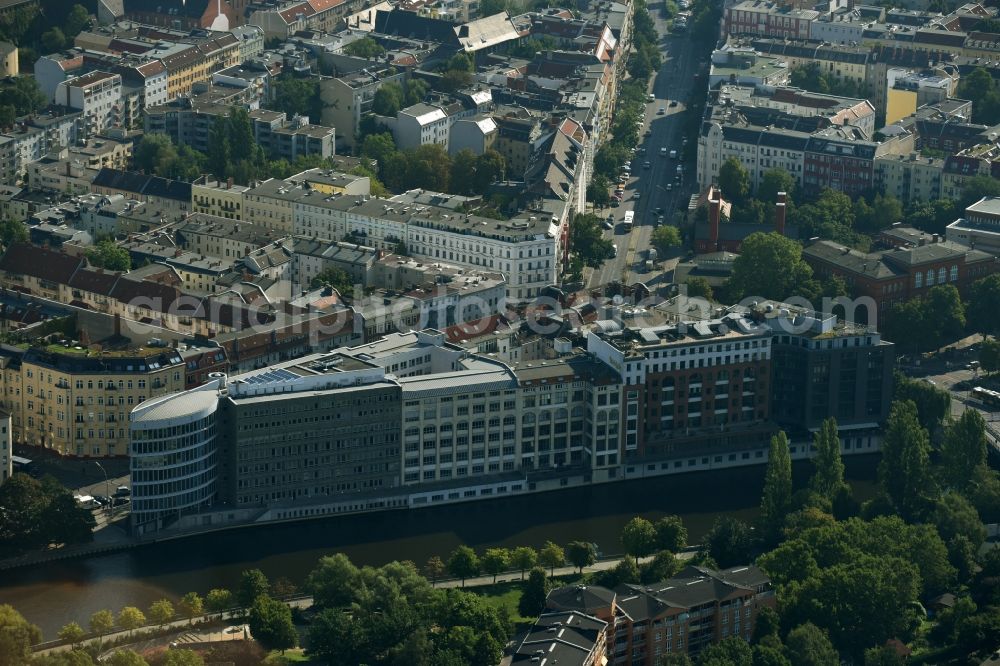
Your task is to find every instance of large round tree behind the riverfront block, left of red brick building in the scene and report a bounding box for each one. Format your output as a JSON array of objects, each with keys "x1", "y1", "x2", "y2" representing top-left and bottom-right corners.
[{"x1": 728, "y1": 232, "x2": 813, "y2": 300}]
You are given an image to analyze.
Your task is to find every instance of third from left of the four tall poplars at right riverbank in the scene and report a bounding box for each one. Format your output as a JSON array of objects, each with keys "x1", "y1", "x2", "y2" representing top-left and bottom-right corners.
[{"x1": 878, "y1": 400, "x2": 935, "y2": 520}]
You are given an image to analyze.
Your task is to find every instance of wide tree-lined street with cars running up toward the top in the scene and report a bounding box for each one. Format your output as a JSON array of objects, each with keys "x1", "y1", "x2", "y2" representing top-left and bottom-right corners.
[{"x1": 588, "y1": 16, "x2": 697, "y2": 288}]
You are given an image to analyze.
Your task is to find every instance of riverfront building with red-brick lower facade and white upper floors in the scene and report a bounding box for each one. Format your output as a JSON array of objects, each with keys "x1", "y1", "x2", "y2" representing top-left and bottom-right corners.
[{"x1": 587, "y1": 308, "x2": 771, "y2": 462}]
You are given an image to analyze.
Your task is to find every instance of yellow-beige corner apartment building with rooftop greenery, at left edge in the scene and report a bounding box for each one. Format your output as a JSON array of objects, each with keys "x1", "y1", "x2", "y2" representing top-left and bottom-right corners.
[{"x1": 0, "y1": 345, "x2": 185, "y2": 458}]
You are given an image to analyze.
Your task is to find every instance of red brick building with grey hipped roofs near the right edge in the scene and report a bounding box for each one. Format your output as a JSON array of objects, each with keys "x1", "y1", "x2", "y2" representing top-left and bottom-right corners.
[{"x1": 802, "y1": 230, "x2": 1000, "y2": 312}]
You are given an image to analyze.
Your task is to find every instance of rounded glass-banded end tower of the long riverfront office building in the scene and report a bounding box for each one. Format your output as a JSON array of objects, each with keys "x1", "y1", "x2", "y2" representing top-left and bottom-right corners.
[{"x1": 129, "y1": 375, "x2": 226, "y2": 535}]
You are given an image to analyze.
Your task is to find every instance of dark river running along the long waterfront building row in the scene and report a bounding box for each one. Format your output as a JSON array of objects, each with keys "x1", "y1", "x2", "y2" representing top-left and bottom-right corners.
[{"x1": 0, "y1": 456, "x2": 878, "y2": 639}]
